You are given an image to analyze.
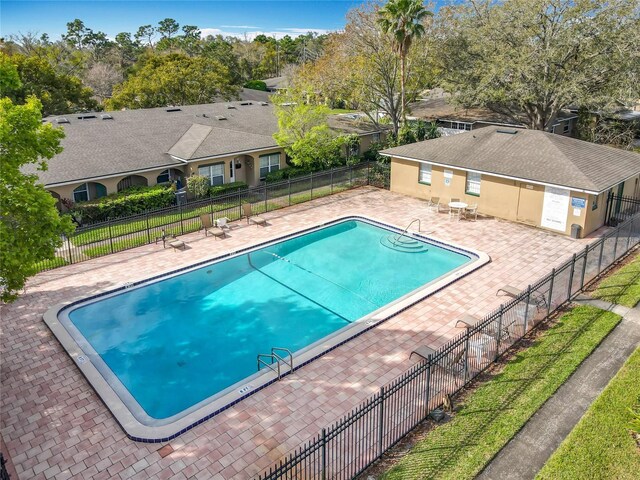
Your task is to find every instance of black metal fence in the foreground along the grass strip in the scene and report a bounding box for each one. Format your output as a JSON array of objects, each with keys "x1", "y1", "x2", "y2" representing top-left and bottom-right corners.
[{"x1": 257, "y1": 215, "x2": 640, "y2": 480}]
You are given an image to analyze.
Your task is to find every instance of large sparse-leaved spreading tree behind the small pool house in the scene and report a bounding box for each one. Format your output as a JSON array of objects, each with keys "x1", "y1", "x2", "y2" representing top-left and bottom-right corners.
[{"x1": 437, "y1": 0, "x2": 640, "y2": 130}]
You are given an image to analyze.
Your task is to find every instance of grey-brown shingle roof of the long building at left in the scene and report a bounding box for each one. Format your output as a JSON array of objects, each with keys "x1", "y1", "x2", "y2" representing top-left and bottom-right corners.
[{"x1": 31, "y1": 102, "x2": 278, "y2": 185}]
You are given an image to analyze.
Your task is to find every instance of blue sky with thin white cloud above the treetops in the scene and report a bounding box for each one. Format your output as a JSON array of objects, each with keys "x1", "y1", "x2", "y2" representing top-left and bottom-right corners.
[{"x1": 0, "y1": 0, "x2": 370, "y2": 40}]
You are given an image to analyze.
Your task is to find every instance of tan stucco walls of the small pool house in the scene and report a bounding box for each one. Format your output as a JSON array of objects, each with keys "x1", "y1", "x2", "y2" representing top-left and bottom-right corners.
[{"x1": 391, "y1": 158, "x2": 636, "y2": 236}]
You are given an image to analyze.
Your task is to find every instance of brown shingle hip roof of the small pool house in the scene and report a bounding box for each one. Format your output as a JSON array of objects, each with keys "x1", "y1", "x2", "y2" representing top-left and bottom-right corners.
[{"x1": 381, "y1": 126, "x2": 640, "y2": 192}]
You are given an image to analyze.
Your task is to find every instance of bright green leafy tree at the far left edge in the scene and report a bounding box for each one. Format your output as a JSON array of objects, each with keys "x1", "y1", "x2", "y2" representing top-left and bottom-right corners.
[{"x1": 0, "y1": 97, "x2": 73, "y2": 302}]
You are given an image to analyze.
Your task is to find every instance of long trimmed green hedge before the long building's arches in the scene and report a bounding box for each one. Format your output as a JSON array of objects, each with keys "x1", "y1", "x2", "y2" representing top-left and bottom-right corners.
[{"x1": 72, "y1": 185, "x2": 175, "y2": 223}]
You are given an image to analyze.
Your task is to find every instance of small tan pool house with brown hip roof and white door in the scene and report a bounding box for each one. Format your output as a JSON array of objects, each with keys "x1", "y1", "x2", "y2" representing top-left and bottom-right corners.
[{"x1": 383, "y1": 127, "x2": 640, "y2": 236}]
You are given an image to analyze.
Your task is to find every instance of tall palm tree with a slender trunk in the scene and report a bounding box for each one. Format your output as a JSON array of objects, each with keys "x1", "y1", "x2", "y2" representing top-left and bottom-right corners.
[{"x1": 378, "y1": 0, "x2": 433, "y2": 122}]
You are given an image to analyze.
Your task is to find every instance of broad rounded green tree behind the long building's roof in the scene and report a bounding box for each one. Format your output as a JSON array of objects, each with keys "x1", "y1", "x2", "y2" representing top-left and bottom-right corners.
[{"x1": 106, "y1": 53, "x2": 239, "y2": 110}]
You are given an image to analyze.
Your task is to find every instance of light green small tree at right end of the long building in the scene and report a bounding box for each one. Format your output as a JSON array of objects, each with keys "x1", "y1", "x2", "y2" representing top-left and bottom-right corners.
[{"x1": 273, "y1": 91, "x2": 344, "y2": 170}]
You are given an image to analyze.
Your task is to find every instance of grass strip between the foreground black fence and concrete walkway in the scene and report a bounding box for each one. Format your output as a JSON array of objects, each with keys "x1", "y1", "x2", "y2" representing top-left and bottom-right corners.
[{"x1": 383, "y1": 306, "x2": 621, "y2": 480}]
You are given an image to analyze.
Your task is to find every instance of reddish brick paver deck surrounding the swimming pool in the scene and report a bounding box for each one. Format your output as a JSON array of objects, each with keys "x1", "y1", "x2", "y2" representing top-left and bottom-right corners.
[{"x1": 0, "y1": 187, "x2": 600, "y2": 479}]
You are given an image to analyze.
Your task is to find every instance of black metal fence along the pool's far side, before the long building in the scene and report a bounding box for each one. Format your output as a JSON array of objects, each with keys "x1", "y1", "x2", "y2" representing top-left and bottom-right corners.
[{"x1": 37, "y1": 163, "x2": 388, "y2": 271}]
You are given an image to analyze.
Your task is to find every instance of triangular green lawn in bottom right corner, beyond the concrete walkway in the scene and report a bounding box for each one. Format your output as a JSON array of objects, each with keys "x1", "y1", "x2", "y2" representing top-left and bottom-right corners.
[{"x1": 536, "y1": 349, "x2": 640, "y2": 480}]
